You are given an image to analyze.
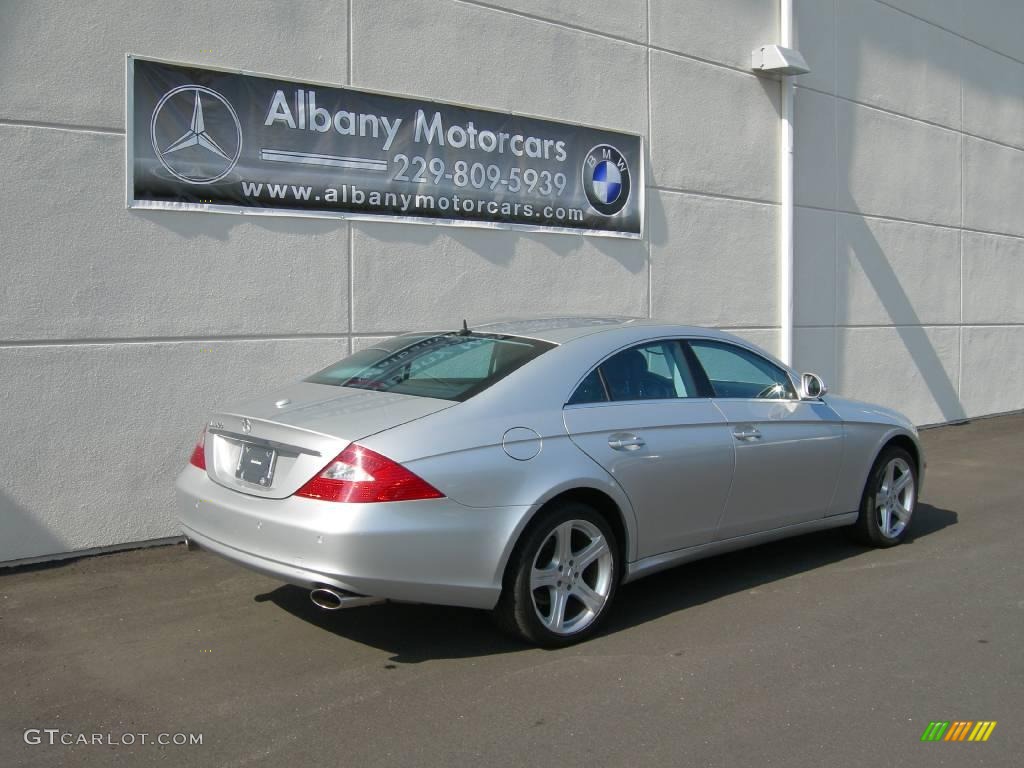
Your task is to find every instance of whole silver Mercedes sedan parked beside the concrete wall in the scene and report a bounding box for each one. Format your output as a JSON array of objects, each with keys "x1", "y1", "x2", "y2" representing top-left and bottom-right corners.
[{"x1": 176, "y1": 317, "x2": 925, "y2": 646}]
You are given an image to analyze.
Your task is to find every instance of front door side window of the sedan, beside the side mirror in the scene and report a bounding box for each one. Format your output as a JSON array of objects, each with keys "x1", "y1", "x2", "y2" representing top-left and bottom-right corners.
[{"x1": 689, "y1": 340, "x2": 797, "y2": 400}]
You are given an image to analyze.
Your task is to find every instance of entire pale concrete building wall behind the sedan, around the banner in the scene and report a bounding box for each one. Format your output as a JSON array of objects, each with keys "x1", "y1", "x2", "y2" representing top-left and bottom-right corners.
[{"x1": 0, "y1": 0, "x2": 1024, "y2": 561}]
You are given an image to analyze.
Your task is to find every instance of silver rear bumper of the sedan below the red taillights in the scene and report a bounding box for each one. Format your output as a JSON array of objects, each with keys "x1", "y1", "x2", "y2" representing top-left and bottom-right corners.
[{"x1": 175, "y1": 466, "x2": 529, "y2": 608}]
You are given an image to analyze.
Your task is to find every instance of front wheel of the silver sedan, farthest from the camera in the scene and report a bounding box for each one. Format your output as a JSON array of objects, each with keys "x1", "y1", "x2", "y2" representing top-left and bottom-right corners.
[{"x1": 853, "y1": 445, "x2": 918, "y2": 547}]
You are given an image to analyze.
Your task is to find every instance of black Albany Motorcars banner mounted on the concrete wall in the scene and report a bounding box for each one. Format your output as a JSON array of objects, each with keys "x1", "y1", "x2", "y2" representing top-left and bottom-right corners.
[{"x1": 127, "y1": 56, "x2": 644, "y2": 238}]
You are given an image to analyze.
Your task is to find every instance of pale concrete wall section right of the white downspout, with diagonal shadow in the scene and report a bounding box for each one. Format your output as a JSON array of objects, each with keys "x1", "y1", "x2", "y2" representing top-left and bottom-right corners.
[{"x1": 796, "y1": 0, "x2": 1024, "y2": 424}]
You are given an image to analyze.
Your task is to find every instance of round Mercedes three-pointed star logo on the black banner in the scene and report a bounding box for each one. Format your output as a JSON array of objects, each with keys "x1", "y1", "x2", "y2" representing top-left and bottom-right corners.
[{"x1": 150, "y1": 85, "x2": 242, "y2": 184}]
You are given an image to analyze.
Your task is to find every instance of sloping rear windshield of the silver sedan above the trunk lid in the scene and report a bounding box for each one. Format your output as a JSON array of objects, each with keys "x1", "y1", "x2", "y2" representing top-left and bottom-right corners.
[{"x1": 306, "y1": 333, "x2": 555, "y2": 401}]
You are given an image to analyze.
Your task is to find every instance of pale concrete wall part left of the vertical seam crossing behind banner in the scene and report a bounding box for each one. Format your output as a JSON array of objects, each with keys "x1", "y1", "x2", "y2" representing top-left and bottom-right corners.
[{"x1": 0, "y1": 0, "x2": 351, "y2": 561}]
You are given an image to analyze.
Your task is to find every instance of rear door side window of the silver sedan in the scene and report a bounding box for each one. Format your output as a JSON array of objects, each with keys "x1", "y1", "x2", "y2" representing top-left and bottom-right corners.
[{"x1": 567, "y1": 341, "x2": 698, "y2": 406}]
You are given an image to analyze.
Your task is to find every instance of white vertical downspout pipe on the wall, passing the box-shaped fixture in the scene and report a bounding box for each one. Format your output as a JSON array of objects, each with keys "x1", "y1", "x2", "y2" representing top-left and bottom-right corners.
[{"x1": 778, "y1": 0, "x2": 795, "y2": 366}]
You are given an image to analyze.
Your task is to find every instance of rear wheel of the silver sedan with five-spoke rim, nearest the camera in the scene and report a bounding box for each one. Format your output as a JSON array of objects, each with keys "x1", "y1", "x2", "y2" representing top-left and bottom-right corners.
[{"x1": 494, "y1": 502, "x2": 621, "y2": 648}]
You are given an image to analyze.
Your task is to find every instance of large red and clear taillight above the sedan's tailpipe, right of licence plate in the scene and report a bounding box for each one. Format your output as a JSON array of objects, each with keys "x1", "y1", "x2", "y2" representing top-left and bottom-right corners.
[{"x1": 295, "y1": 444, "x2": 444, "y2": 504}]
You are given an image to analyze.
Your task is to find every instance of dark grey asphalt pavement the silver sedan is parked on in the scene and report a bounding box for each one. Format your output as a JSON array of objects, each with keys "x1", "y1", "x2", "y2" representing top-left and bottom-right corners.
[{"x1": 0, "y1": 415, "x2": 1024, "y2": 768}]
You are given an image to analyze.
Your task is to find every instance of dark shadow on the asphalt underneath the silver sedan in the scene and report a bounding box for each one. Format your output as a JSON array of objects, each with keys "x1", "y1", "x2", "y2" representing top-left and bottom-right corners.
[{"x1": 254, "y1": 504, "x2": 957, "y2": 664}]
